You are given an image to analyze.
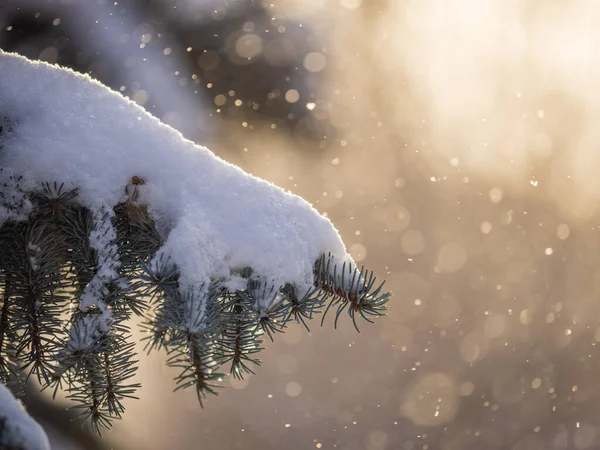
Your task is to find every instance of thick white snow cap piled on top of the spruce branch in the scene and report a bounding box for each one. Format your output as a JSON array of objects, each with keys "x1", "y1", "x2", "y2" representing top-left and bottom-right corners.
[{"x1": 0, "y1": 51, "x2": 354, "y2": 298}]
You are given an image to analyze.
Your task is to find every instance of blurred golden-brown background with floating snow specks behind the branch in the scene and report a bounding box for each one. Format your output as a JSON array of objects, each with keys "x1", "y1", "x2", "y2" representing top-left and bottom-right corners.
[{"x1": 0, "y1": 0, "x2": 600, "y2": 450}]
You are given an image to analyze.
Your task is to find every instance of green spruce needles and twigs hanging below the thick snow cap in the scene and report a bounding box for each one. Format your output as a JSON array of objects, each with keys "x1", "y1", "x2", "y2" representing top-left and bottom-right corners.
[{"x1": 0, "y1": 173, "x2": 390, "y2": 433}]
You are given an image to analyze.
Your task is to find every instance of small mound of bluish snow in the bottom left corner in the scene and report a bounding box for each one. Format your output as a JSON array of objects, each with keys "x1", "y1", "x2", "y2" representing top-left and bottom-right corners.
[{"x1": 0, "y1": 384, "x2": 50, "y2": 450}]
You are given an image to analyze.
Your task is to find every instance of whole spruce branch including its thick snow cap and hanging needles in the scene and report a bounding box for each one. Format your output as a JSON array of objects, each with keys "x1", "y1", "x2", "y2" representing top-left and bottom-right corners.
[{"x1": 0, "y1": 52, "x2": 389, "y2": 442}]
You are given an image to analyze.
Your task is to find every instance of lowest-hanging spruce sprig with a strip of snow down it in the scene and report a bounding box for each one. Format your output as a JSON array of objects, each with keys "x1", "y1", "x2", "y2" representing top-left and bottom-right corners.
[{"x1": 46, "y1": 202, "x2": 145, "y2": 433}]
